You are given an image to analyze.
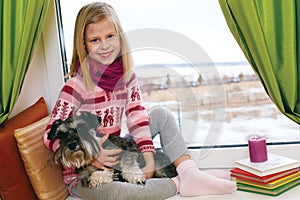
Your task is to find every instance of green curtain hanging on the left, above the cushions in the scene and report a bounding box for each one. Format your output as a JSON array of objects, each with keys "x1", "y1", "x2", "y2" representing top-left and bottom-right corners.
[{"x1": 0, "y1": 0, "x2": 50, "y2": 124}]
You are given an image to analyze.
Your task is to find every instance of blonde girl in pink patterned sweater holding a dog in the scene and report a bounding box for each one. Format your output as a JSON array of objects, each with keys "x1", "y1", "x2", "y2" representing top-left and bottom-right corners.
[{"x1": 44, "y1": 2, "x2": 236, "y2": 199}]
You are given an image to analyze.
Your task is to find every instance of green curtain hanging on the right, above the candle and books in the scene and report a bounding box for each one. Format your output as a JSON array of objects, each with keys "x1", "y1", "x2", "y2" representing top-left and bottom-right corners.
[{"x1": 219, "y1": 0, "x2": 300, "y2": 124}]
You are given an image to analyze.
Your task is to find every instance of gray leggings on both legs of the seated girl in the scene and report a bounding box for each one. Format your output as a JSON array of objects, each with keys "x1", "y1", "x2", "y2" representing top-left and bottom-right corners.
[{"x1": 77, "y1": 107, "x2": 187, "y2": 200}]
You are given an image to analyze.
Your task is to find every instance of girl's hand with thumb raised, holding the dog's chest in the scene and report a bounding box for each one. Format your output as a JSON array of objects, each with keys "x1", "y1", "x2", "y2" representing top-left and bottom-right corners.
[{"x1": 92, "y1": 135, "x2": 122, "y2": 169}]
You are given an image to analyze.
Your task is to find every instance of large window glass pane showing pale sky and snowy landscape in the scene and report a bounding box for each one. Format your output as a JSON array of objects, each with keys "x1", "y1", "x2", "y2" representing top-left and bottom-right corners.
[{"x1": 60, "y1": 0, "x2": 300, "y2": 146}]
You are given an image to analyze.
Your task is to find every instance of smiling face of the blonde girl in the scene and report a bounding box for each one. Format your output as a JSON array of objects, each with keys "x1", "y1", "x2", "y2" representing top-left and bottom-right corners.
[{"x1": 85, "y1": 19, "x2": 121, "y2": 65}]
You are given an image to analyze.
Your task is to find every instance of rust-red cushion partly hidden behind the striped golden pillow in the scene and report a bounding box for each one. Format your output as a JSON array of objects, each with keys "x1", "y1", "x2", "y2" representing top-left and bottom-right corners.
[{"x1": 0, "y1": 97, "x2": 48, "y2": 200}]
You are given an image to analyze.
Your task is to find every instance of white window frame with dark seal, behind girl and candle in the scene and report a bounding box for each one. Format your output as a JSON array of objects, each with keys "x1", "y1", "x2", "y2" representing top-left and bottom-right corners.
[{"x1": 55, "y1": 0, "x2": 300, "y2": 169}]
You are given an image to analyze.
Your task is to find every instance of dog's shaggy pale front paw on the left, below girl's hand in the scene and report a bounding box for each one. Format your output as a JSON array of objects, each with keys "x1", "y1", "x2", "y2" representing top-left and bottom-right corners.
[{"x1": 89, "y1": 170, "x2": 113, "y2": 188}]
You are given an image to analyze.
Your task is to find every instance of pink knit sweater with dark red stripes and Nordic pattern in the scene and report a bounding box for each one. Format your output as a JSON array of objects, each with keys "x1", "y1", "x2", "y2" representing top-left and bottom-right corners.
[{"x1": 44, "y1": 74, "x2": 155, "y2": 152}]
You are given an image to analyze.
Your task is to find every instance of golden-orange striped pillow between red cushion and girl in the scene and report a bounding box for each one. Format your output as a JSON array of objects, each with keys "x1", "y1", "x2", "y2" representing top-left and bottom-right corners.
[{"x1": 15, "y1": 116, "x2": 69, "y2": 200}]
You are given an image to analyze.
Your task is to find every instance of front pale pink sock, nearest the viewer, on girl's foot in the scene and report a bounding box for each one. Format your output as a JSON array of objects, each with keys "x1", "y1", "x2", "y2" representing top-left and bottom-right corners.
[{"x1": 177, "y1": 160, "x2": 237, "y2": 196}]
